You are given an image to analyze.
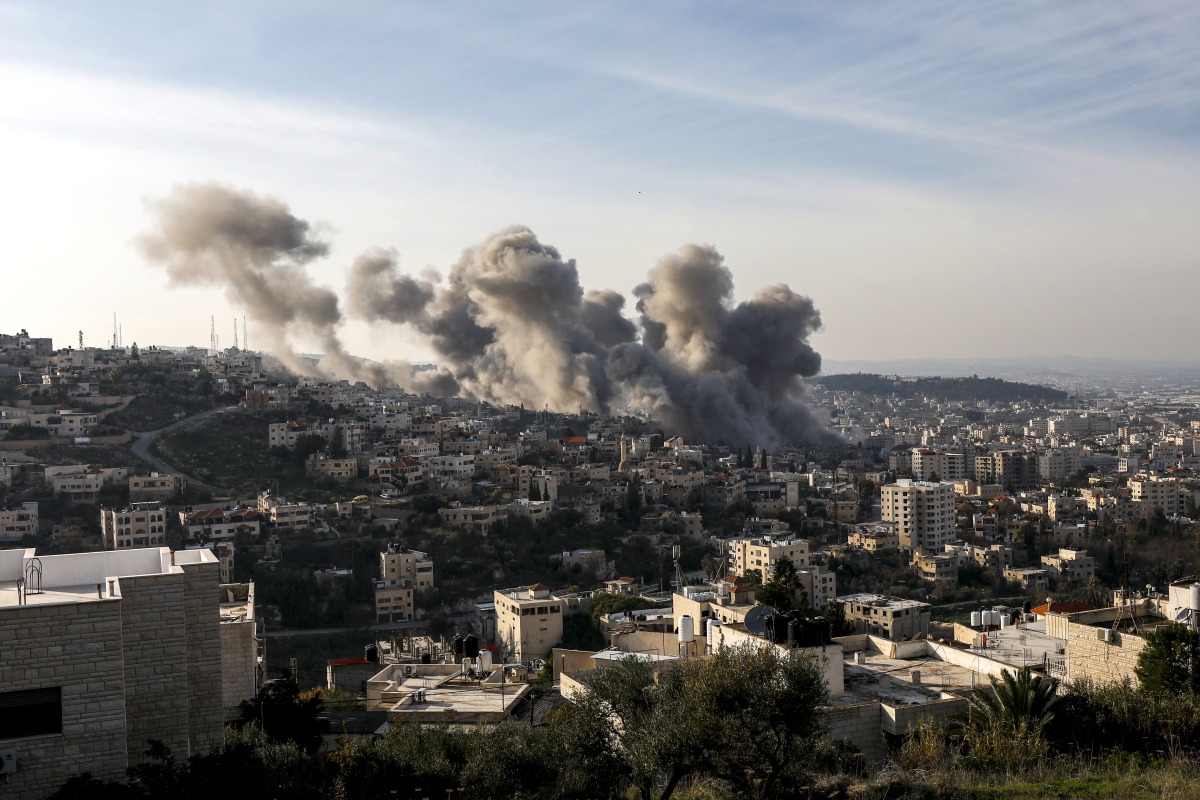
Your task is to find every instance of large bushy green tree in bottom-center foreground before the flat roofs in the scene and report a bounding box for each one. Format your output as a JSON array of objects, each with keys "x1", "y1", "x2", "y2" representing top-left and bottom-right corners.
[{"x1": 563, "y1": 644, "x2": 827, "y2": 800}]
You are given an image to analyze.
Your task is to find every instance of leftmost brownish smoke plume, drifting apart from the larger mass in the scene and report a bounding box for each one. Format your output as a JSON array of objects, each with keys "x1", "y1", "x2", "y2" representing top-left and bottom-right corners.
[{"x1": 138, "y1": 184, "x2": 388, "y2": 384}]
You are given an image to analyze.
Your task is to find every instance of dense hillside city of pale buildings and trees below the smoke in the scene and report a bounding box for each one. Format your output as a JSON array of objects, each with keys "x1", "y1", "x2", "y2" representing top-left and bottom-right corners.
[{"x1": 0, "y1": 330, "x2": 1200, "y2": 798}]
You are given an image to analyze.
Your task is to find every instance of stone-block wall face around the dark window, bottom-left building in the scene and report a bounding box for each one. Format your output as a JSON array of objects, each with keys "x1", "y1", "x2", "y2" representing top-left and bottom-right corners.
[{"x1": 0, "y1": 600, "x2": 127, "y2": 800}]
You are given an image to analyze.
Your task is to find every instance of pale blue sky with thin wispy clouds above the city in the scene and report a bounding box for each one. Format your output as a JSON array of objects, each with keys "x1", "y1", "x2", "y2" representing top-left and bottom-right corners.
[{"x1": 0, "y1": 0, "x2": 1200, "y2": 361}]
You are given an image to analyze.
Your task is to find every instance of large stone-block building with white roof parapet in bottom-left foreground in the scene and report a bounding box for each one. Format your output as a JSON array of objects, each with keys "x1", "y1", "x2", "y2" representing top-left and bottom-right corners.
[{"x1": 0, "y1": 547, "x2": 248, "y2": 800}]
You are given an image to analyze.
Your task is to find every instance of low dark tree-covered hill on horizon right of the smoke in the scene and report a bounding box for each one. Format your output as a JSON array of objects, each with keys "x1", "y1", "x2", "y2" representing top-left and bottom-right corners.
[{"x1": 812, "y1": 372, "x2": 1068, "y2": 403}]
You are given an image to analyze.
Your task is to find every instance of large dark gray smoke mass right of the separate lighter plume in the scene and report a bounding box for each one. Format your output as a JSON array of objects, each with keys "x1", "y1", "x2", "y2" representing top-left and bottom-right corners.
[{"x1": 349, "y1": 228, "x2": 834, "y2": 447}]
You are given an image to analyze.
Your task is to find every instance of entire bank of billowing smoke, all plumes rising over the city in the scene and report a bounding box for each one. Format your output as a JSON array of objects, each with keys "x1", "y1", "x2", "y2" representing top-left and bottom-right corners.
[{"x1": 142, "y1": 185, "x2": 835, "y2": 447}]
